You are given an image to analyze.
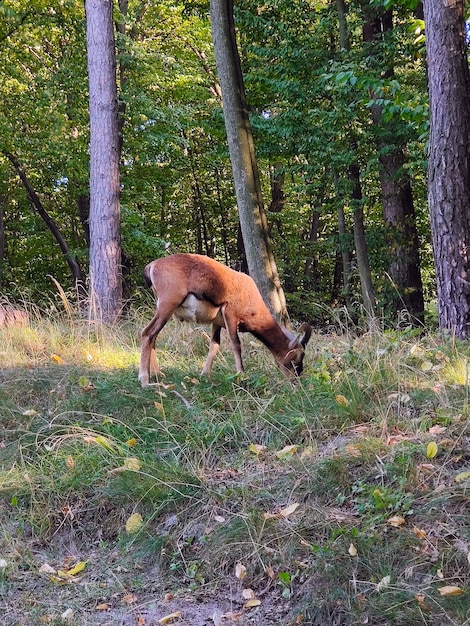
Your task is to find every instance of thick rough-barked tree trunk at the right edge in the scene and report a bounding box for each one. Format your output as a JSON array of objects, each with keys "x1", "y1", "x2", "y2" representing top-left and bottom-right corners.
[{"x1": 424, "y1": 0, "x2": 470, "y2": 339}]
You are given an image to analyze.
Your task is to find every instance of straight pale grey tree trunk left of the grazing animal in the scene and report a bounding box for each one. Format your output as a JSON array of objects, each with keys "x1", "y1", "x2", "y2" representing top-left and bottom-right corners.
[{"x1": 85, "y1": 0, "x2": 122, "y2": 322}]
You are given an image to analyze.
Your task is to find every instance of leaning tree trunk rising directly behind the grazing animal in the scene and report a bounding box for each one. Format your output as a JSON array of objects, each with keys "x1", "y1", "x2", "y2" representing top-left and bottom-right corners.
[{"x1": 210, "y1": 0, "x2": 287, "y2": 322}]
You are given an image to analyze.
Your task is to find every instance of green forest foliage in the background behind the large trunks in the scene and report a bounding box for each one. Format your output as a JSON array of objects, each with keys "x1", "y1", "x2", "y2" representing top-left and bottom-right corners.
[{"x1": 0, "y1": 0, "x2": 434, "y2": 321}]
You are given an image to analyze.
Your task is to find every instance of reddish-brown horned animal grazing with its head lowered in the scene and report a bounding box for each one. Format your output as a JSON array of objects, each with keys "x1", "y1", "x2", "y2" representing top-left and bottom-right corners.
[{"x1": 139, "y1": 254, "x2": 312, "y2": 387}]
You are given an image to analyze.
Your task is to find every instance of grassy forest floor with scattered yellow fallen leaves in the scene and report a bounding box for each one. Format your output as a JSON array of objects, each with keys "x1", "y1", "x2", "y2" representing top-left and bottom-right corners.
[{"x1": 0, "y1": 304, "x2": 470, "y2": 626}]
